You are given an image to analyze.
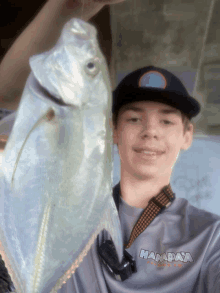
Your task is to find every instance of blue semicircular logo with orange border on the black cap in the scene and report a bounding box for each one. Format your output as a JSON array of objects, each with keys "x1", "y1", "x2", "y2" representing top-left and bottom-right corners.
[{"x1": 138, "y1": 71, "x2": 167, "y2": 89}]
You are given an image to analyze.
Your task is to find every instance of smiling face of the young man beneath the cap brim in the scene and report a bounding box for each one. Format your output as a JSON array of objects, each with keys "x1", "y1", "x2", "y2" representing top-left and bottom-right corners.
[{"x1": 114, "y1": 101, "x2": 193, "y2": 180}]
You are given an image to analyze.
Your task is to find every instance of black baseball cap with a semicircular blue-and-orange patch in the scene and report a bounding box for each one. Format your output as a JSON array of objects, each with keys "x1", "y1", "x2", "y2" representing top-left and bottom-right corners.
[{"x1": 112, "y1": 66, "x2": 201, "y2": 119}]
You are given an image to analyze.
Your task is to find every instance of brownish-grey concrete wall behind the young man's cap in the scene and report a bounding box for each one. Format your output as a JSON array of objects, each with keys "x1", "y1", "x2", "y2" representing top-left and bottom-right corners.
[{"x1": 111, "y1": 0, "x2": 220, "y2": 135}]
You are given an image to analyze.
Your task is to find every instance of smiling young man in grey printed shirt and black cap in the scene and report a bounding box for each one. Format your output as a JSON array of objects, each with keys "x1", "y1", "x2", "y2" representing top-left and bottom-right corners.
[{"x1": 58, "y1": 66, "x2": 220, "y2": 293}]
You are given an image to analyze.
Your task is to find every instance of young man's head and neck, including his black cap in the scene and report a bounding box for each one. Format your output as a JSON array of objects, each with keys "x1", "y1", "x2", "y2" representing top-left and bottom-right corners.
[{"x1": 113, "y1": 67, "x2": 195, "y2": 208}]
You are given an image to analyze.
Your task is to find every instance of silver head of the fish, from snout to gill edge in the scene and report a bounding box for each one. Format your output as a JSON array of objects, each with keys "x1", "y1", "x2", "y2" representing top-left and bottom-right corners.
[{"x1": 30, "y1": 18, "x2": 111, "y2": 107}]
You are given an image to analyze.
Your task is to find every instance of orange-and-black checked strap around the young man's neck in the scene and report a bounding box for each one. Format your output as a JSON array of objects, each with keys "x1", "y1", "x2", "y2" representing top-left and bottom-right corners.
[{"x1": 113, "y1": 182, "x2": 175, "y2": 249}]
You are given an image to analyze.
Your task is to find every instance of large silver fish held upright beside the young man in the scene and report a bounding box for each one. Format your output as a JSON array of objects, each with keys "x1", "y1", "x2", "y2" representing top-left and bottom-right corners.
[{"x1": 0, "y1": 19, "x2": 123, "y2": 293}]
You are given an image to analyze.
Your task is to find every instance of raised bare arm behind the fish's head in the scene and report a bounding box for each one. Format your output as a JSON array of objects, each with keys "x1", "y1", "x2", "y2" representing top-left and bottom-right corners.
[{"x1": 0, "y1": 0, "x2": 124, "y2": 110}]
